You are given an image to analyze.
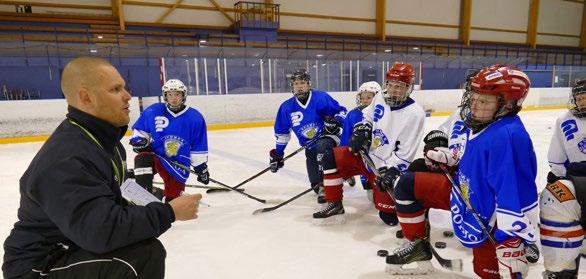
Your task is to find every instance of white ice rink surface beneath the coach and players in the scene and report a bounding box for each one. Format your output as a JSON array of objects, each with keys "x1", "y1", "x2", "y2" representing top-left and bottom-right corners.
[{"x1": 0, "y1": 110, "x2": 586, "y2": 279}]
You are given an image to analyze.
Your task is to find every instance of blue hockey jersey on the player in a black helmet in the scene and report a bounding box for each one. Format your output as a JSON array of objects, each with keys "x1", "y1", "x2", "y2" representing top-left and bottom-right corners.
[{"x1": 275, "y1": 89, "x2": 346, "y2": 156}]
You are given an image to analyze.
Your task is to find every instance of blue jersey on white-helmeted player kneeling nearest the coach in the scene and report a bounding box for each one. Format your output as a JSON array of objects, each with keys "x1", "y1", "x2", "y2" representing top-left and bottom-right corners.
[{"x1": 130, "y1": 103, "x2": 208, "y2": 183}]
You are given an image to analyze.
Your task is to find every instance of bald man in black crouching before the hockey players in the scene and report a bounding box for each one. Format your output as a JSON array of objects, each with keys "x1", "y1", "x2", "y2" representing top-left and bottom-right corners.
[{"x1": 2, "y1": 57, "x2": 201, "y2": 279}]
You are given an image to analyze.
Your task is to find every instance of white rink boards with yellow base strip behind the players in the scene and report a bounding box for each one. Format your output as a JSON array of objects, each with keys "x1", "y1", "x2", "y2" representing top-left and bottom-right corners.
[{"x1": 0, "y1": 88, "x2": 570, "y2": 143}]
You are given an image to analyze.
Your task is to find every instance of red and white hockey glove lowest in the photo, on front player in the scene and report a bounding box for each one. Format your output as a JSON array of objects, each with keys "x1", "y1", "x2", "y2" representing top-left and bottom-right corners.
[{"x1": 496, "y1": 237, "x2": 529, "y2": 279}]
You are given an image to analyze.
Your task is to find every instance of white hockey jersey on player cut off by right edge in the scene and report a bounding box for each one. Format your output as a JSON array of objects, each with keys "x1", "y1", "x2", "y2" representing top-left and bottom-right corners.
[{"x1": 547, "y1": 111, "x2": 586, "y2": 177}]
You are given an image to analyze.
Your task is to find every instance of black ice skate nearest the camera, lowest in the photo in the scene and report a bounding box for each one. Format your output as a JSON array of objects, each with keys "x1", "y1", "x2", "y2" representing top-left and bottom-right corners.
[{"x1": 386, "y1": 238, "x2": 435, "y2": 275}]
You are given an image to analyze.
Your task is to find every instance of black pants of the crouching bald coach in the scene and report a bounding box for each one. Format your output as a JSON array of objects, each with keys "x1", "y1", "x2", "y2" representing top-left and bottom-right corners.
[{"x1": 21, "y1": 238, "x2": 166, "y2": 279}]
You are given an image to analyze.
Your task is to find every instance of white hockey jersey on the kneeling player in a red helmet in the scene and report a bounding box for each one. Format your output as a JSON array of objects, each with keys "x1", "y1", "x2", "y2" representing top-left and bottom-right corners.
[{"x1": 362, "y1": 94, "x2": 425, "y2": 172}]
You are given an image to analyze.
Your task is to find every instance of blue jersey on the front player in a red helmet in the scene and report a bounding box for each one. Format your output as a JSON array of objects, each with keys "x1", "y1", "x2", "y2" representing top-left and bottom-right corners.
[{"x1": 451, "y1": 115, "x2": 539, "y2": 247}]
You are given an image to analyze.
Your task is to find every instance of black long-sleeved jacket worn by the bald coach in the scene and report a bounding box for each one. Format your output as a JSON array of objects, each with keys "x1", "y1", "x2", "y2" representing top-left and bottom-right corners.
[{"x1": 2, "y1": 107, "x2": 175, "y2": 278}]
